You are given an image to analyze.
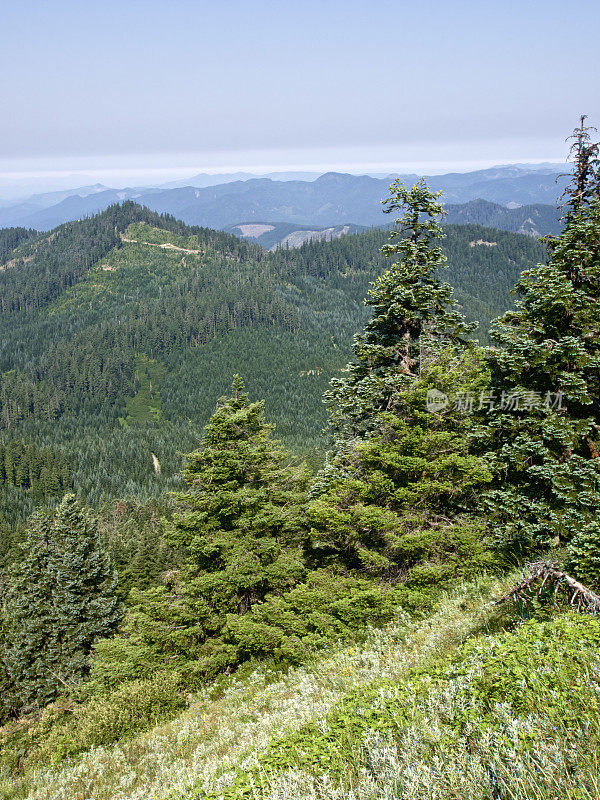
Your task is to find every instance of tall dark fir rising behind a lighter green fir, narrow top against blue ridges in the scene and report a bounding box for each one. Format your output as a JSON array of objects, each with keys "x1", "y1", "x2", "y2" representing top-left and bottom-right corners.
[{"x1": 325, "y1": 178, "x2": 476, "y2": 436}]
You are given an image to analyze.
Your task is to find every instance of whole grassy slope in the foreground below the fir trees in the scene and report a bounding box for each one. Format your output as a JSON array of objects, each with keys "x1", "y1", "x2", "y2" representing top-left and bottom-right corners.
[{"x1": 7, "y1": 575, "x2": 600, "y2": 800}]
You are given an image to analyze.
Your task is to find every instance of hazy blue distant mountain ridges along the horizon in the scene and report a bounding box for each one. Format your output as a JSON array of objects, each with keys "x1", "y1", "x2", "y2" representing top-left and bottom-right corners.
[{"x1": 0, "y1": 166, "x2": 567, "y2": 235}]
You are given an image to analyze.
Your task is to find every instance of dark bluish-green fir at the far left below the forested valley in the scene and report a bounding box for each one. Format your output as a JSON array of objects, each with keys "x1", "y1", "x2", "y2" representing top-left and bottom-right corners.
[{"x1": 2, "y1": 494, "x2": 121, "y2": 707}]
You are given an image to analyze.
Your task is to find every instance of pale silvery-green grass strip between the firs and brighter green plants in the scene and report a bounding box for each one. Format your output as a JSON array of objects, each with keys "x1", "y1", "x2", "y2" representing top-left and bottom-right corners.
[{"x1": 0, "y1": 577, "x2": 520, "y2": 800}]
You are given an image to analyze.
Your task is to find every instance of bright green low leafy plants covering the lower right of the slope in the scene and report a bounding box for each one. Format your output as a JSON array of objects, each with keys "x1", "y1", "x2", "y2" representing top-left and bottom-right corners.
[{"x1": 194, "y1": 613, "x2": 600, "y2": 800}]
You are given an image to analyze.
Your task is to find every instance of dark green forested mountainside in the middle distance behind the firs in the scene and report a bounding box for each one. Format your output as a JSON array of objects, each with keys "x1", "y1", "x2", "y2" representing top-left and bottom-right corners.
[{"x1": 0, "y1": 203, "x2": 545, "y2": 516}]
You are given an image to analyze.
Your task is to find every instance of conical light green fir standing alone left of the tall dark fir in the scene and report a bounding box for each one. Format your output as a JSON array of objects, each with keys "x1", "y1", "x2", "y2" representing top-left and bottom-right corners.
[{"x1": 171, "y1": 376, "x2": 306, "y2": 616}]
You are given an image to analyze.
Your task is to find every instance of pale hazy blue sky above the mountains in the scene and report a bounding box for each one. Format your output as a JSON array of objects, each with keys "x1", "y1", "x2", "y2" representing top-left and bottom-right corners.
[{"x1": 0, "y1": 0, "x2": 600, "y2": 191}]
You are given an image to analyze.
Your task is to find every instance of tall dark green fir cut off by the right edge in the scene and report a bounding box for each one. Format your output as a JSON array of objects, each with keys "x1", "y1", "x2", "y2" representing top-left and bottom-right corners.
[{"x1": 482, "y1": 117, "x2": 600, "y2": 556}]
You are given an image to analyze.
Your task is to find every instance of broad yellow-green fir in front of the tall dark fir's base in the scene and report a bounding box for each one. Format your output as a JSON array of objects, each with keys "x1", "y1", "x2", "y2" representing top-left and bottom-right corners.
[{"x1": 307, "y1": 349, "x2": 493, "y2": 608}]
